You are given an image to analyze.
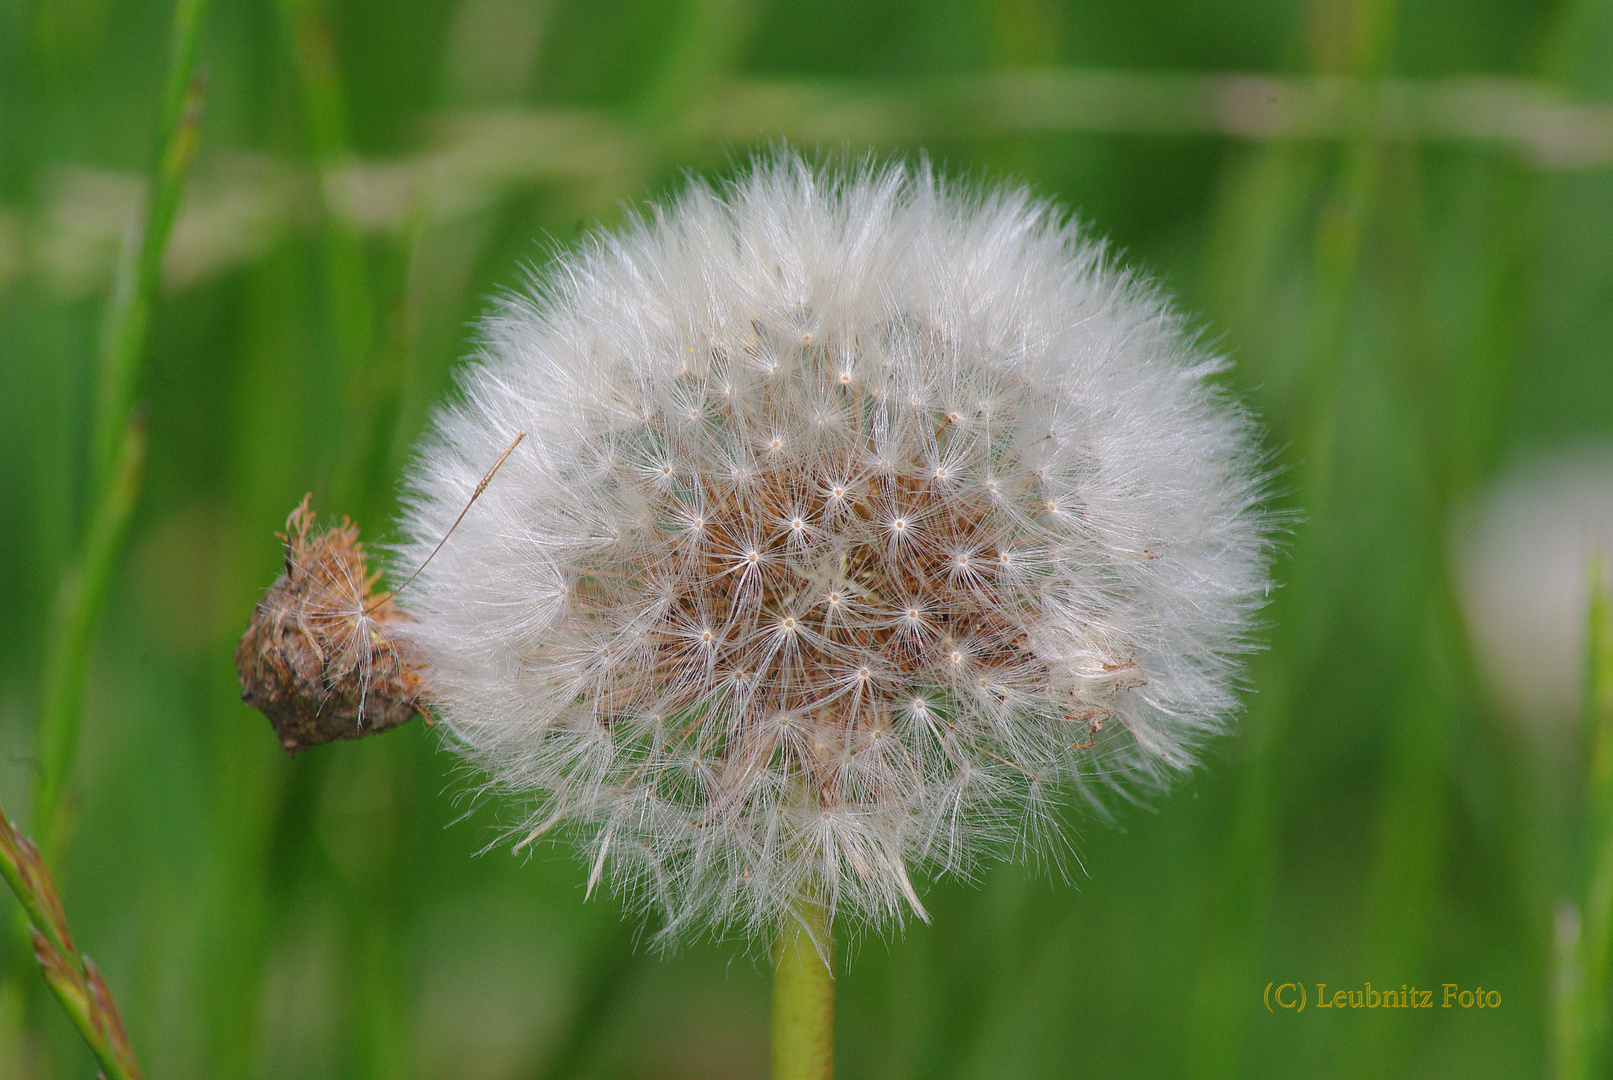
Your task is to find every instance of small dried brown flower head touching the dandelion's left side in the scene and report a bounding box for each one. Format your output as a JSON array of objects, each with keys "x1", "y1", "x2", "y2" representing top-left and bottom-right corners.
[{"x1": 235, "y1": 495, "x2": 424, "y2": 753}]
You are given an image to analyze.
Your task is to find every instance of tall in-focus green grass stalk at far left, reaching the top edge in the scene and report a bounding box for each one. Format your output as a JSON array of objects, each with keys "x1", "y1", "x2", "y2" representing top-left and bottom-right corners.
[{"x1": 34, "y1": 0, "x2": 206, "y2": 861}]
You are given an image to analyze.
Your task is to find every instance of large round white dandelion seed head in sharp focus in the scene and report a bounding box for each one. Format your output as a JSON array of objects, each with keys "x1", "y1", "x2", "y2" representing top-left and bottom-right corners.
[{"x1": 397, "y1": 153, "x2": 1269, "y2": 938}]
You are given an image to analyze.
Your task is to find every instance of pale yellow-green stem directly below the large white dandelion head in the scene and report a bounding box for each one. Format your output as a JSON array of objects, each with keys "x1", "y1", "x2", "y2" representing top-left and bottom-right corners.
[{"x1": 773, "y1": 904, "x2": 834, "y2": 1080}]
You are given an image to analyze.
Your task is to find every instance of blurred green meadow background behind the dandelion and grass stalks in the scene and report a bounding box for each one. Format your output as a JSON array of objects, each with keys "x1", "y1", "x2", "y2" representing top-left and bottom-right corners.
[{"x1": 0, "y1": 0, "x2": 1613, "y2": 1080}]
